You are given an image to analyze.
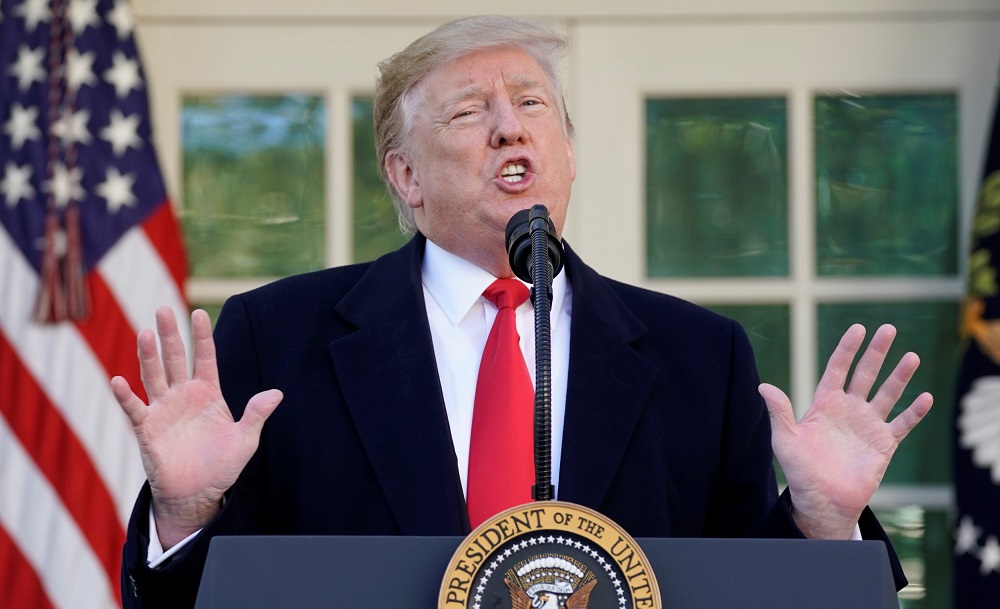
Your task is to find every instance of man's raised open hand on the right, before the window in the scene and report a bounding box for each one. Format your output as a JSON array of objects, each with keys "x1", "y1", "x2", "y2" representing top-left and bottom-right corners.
[{"x1": 759, "y1": 325, "x2": 933, "y2": 539}]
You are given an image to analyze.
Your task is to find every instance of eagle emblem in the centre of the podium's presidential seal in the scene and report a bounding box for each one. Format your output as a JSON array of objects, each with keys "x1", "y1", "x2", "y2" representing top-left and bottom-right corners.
[{"x1": 503, "y1": 554, "x2": 597, "y2": 609}]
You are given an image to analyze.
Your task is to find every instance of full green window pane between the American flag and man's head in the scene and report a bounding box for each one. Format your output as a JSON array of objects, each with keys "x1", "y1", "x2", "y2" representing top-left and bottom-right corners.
[{"x1": 181, "y1": 95, "x2": 326, "y2": 277}]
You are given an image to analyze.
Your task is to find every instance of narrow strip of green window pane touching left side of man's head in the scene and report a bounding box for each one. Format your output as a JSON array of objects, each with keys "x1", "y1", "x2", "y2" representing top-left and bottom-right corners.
[{"x1": 351, "y1": 97, "x2": 408, "y2": 262}]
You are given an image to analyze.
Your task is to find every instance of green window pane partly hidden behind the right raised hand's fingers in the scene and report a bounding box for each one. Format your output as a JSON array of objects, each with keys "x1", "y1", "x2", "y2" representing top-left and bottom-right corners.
[{"x1": 817, "y1": 302, "x2": 959, "y2": 484}]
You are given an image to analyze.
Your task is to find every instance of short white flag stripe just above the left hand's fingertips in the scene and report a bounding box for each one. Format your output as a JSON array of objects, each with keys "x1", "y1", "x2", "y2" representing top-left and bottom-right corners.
[{"x1": 97, "y1": 227, "x2": 190, "y2": 346}]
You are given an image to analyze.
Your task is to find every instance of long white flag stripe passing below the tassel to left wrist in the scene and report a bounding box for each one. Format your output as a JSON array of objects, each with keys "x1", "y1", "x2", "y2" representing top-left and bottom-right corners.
[{"x1": 0, "y1": 224, "x2": 146, "y2": 527}]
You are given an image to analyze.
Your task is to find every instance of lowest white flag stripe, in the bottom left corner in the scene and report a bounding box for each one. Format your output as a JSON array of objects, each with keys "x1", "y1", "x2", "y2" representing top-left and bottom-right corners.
[{"x1": 0, "y1": 416, "x2": 118, "y2": 609}]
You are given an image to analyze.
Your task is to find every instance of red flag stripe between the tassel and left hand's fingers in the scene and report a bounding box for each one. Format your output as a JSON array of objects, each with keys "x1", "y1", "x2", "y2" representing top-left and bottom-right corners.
[{"x1": 76, "y1": 270, "x2": 146, "y2": 402}]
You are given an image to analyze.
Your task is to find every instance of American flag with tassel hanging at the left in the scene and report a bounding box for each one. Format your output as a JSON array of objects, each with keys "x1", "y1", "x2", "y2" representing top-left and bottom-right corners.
[{"x1": 0, "y1": 0, "x2": 187, "y2": 609}]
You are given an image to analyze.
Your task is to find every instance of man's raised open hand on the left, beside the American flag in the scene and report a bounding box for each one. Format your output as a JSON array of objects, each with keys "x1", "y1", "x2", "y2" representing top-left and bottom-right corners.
[{"x1": 111, "y1": 307, "x2": 282, "y2": 549}]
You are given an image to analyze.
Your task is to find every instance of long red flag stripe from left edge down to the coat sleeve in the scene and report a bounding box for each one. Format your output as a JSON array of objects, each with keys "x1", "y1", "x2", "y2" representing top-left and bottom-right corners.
[{"x1": 0, "y1": 333, "x2": 125, "y2": 606}]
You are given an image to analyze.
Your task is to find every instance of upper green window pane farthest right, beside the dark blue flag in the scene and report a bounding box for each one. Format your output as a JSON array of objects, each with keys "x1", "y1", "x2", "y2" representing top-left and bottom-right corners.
[{"x1": 816, "y1": 94, "x2": 958, "y2": 276}]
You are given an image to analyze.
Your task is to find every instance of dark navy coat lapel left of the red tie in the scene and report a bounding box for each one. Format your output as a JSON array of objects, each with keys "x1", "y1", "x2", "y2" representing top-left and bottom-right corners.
[{"x1": 330, "y1": 236, "x2": 469, "y2": 535}]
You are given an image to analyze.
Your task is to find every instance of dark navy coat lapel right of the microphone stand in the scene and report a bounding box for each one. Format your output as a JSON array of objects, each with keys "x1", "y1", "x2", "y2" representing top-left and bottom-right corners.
[{"x1": 556, "y1": 248, "x2": 656, "y2": 509}]
